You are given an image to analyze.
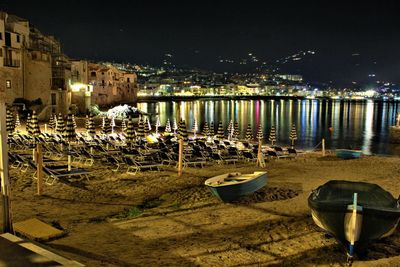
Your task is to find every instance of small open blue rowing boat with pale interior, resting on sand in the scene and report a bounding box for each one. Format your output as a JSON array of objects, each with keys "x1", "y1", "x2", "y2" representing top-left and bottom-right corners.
[{"x1": 205, "y1": 172, "x2": 267, "y2": 202}]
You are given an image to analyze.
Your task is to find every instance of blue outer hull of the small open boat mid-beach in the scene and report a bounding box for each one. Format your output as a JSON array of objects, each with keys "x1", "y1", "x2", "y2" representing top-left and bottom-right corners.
[{"x1": 208, "y1": 173, "x2": 268, "y2": 202}]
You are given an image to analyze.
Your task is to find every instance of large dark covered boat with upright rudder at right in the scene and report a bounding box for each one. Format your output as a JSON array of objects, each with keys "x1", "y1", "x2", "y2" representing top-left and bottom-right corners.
[{"x1": 308, "y1": 181, "x2": 400, "y2": 257}]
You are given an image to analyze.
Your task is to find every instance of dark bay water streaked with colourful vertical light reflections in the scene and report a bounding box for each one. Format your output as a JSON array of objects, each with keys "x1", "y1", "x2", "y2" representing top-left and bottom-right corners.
[{"x1": 138, "y1": 100, "x2": 400, "y2": 154}]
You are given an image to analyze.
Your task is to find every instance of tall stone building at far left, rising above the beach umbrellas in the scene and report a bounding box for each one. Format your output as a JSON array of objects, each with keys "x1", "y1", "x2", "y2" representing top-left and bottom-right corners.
[{"x1": 0, "y1": 12, "x2": 71, "y2": 118}]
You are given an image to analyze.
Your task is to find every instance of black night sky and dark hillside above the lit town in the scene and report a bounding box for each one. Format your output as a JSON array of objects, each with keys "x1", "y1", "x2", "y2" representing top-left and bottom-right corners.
[{"x1": 0, "y1": 0, "x2": 400, "y2": 85}]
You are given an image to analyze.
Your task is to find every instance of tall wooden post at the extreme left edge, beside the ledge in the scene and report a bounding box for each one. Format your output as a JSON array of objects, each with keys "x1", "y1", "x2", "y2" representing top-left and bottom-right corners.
[{"x1": 0, "y1": 101, "x2": 12, "y2": 233}]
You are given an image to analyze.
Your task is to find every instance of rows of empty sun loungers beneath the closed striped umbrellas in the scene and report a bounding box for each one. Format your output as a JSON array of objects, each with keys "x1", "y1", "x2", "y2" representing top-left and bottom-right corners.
[{"x1": 9, "y1": 134, "x2": 296, "y2": 184}]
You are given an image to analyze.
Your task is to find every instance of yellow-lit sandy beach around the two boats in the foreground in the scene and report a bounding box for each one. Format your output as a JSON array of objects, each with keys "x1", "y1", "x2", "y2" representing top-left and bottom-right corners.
[{"x1": 0, "y1": 153, "x2": 400, "y2": 266}]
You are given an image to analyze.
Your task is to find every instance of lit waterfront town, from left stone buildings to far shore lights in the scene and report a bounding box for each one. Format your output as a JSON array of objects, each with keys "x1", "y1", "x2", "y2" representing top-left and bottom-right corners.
[{"x1": 0, "y1": 12, "x2": 400, "y2": 119}]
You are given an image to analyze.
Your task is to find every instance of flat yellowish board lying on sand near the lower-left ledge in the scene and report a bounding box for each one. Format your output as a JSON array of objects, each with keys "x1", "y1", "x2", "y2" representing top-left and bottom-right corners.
[{"x1": 13, "y1": 218, "x2": 64, "y2": 240}]
